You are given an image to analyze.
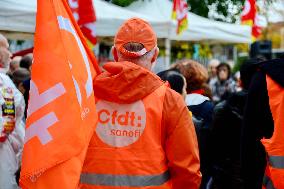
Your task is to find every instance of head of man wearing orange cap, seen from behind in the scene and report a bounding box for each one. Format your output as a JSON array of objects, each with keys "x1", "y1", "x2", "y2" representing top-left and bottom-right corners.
[{"x1": 113, "y1": 18, "x2": 158, "y2": 69}]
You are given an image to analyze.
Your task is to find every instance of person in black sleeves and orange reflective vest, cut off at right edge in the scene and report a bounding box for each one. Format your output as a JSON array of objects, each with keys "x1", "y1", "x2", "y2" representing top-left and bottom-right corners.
[{"x1": 241, "y1": 58, "x2": 284, "y2": 189}]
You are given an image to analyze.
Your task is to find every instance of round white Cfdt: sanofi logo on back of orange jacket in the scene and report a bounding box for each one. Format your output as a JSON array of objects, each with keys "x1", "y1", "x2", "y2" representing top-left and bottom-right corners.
[{"x1": 96, "y1": 100, "x2": 146, "y2": 147}]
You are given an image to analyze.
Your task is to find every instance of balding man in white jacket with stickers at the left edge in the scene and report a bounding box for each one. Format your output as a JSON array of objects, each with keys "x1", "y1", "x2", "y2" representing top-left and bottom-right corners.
[{"x1": 0, "y1": 34, "x2": 25, "y2": 189}]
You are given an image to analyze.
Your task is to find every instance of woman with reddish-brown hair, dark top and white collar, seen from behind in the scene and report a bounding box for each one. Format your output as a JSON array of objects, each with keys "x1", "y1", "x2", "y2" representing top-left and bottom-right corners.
[{"x1": 173, "y1": 60, "x2": 214, "y2": 189}]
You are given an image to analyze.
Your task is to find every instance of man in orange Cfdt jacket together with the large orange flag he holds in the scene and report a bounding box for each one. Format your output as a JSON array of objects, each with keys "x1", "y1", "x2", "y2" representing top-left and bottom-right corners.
[{"x1": 20, "y1": 0, "x2": 201, "y2": 189}]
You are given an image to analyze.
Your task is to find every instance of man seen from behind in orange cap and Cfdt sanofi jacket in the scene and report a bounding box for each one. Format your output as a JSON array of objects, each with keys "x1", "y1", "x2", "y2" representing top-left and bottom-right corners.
[{"x1": 80, "y1": 18, "x2": 201, "y2": 189}]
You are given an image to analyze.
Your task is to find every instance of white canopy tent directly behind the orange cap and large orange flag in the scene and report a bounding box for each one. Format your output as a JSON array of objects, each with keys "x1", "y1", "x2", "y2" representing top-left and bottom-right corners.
[{"x1": 0, "y1": 0, "x2": 169, "y2": 38}]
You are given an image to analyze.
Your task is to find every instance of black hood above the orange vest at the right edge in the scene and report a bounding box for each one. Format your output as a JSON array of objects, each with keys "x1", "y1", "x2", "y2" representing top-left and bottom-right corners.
[{"x1": 261, "y1": 59, "x2": 284, "y2": 87}]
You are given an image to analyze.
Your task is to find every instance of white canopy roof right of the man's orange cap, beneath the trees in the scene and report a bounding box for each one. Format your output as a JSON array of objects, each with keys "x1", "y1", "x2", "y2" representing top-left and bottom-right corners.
[{"x1": 127, "y1": 0, "x2": 251, "y2": 43}]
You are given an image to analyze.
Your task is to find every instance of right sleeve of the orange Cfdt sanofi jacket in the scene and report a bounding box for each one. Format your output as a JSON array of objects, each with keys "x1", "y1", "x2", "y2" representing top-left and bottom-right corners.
[{"x1": 163, "y1": 89, "x2": 201, "y2": 189}]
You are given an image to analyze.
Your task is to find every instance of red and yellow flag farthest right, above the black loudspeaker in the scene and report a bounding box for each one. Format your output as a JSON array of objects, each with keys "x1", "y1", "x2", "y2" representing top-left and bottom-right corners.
[{"x1": 241, "y1": 0, "x2": 261, "y2": 41}]
